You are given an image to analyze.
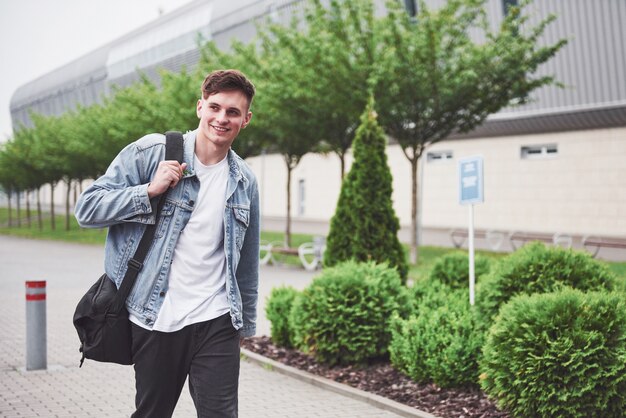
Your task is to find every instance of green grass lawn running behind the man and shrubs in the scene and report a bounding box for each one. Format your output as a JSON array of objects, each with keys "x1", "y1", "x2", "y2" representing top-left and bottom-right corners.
[{"x1": 0, "y1": 208, "x2": 626, "y2": 282}]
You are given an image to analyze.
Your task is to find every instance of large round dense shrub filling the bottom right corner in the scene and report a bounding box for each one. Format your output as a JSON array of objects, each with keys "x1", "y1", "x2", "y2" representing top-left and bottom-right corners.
[{"x1": 481, "y1": 289, "x2": 626, "y2": 418}]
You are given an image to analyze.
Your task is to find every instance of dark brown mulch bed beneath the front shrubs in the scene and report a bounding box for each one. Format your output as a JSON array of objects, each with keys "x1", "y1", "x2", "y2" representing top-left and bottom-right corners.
[{"x1": 243, "y1": 336, "x2": 509, "y2": 418}]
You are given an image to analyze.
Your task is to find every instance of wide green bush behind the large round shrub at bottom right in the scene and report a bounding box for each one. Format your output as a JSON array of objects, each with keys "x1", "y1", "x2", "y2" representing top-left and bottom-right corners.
[{"x1": 476, "y1": 242, "x2": 615, "y2": 318}]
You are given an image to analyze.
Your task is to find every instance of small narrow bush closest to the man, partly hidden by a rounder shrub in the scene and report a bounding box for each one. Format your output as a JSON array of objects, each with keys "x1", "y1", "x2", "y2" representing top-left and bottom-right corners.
[{"x1": 265, "y1": 286, "x2": 299, "y2": 348}]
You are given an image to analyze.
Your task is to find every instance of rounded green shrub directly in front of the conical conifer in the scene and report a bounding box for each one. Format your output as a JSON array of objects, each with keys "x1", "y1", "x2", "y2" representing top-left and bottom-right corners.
[{"x1": 290, "y1": 261, "x2": 408, "y2": 365}]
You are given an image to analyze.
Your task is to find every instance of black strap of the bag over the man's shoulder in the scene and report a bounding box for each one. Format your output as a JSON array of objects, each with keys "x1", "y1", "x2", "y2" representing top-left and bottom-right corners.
[{"x1": 107, "y1": 131, "x2": 183, "y2": 313}]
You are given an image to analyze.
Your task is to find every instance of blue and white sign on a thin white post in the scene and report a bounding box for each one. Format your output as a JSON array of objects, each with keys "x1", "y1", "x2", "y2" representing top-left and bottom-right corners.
[{"x1": 459, "y1": 157, "x2": 484, "y2": 305}]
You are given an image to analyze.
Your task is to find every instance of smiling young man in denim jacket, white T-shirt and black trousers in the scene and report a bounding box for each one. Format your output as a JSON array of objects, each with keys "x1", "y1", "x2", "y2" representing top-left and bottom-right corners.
[{"x1": 75, "y1": 70, "x2": 259, "y2": 418}]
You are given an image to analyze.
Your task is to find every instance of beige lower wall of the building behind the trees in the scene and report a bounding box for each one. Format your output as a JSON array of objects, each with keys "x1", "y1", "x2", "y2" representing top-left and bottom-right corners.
[{"x1": 249, "y1": 128, "x2": 626, "y2": 237}]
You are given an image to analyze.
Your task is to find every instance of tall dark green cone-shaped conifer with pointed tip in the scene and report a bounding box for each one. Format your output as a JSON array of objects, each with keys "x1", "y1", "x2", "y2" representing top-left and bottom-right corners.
[{"x1": 324, "y1": 99, "x2": 407, "y2": 279}]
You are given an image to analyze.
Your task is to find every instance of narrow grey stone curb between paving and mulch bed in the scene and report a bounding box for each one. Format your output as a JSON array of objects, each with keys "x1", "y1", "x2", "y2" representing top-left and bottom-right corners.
[{"x1": 241, "y1": 347, "x2": 437, "y2": 418}]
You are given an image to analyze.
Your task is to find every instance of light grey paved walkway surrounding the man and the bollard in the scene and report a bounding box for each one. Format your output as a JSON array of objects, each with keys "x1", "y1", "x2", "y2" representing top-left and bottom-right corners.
[{"x1": 0, "y1": 236, "x2": 399, "y2": 418}]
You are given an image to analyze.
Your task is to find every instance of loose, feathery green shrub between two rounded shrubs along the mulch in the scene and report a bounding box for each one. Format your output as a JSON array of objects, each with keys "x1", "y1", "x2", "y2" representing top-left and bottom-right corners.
[{"x1": 389, "y1": 285, "x2": 485, "y2": 387}]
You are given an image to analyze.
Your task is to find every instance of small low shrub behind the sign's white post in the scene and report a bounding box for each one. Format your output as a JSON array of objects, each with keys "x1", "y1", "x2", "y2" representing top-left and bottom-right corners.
[{"x1": 428, "y1": 252, "x2": 490, "y2": 289}]
